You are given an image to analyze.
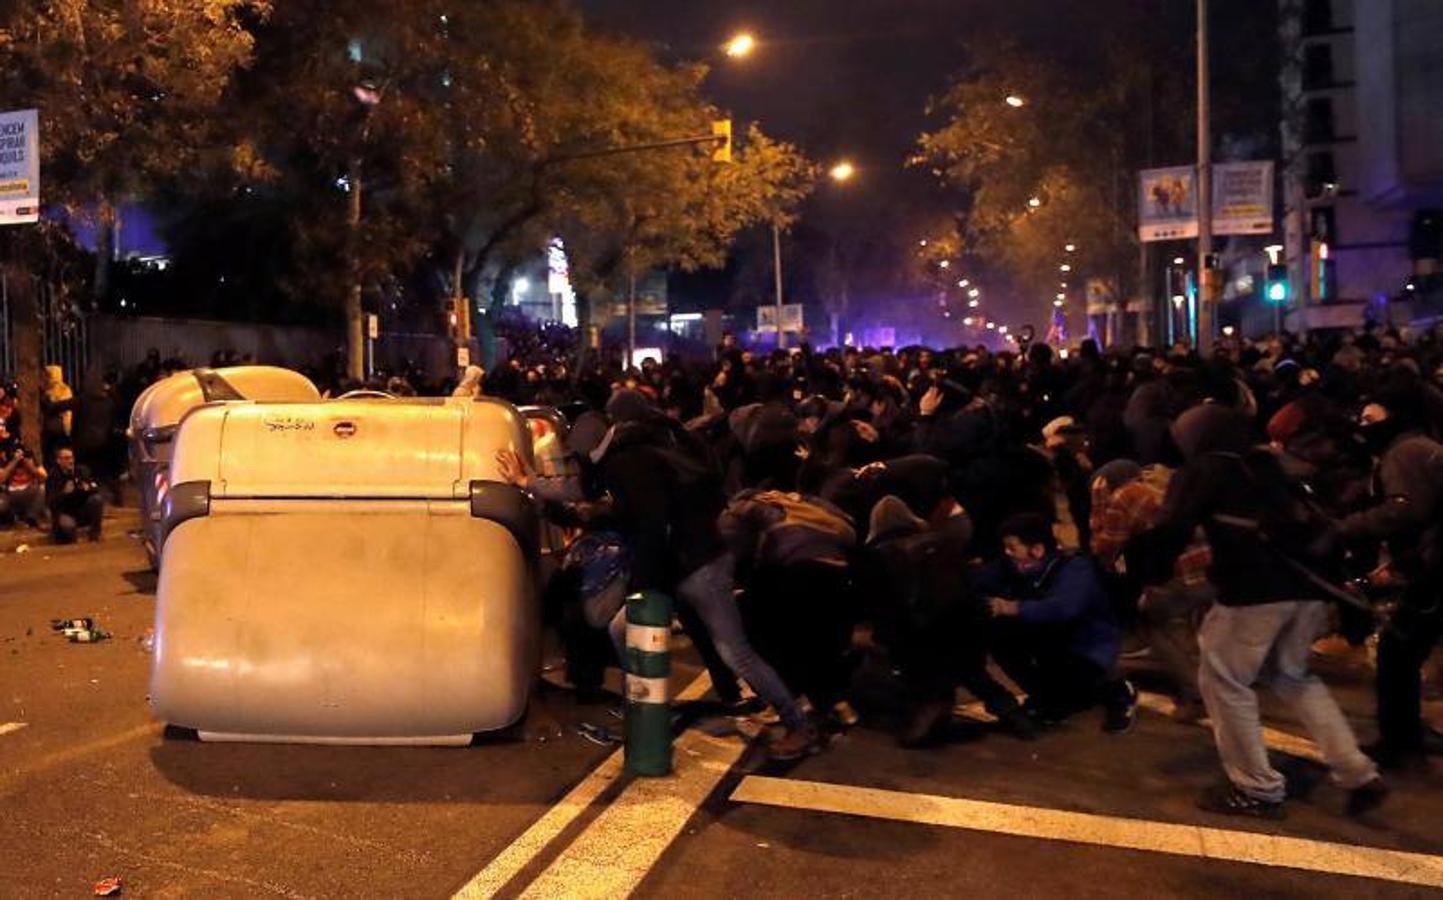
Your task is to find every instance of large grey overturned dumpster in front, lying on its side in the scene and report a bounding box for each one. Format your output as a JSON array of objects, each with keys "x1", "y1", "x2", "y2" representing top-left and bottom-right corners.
[{"x1": 150, "y1": 400, "x2": 540, "y2": 744}]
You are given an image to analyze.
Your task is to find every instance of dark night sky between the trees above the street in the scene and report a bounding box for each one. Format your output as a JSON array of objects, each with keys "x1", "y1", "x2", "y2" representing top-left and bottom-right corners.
[{"x1": 576, "y1": 0, "x2": 1274, "y2": 334}]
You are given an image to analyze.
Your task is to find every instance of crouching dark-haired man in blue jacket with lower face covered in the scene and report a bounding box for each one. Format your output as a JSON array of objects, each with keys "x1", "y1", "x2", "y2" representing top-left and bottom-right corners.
[{"x1": 973, "y1": 515, "x2": 1137, "y2": 733}]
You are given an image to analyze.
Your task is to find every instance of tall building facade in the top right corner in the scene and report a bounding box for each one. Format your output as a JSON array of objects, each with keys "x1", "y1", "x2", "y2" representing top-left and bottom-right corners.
[{"x1": 1280, "y1": 0, "x2": 1443, "y2": 327}]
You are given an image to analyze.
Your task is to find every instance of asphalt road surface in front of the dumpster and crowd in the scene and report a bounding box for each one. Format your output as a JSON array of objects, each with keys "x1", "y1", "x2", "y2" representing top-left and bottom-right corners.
[{"x1": 0, "y1": 516, "x2": 1443, "y2": 897}]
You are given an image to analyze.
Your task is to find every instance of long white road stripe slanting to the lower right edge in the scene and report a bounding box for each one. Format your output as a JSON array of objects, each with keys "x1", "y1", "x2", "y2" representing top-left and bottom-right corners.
[{"x1": 732, "y1": 775, "x2": 1443, "y2": 887}]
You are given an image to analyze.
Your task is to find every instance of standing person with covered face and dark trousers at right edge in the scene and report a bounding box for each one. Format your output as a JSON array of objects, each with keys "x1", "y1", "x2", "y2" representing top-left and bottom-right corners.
[{"x1": 1338, "y1": 385, "x2": 1443, "y2": 769}]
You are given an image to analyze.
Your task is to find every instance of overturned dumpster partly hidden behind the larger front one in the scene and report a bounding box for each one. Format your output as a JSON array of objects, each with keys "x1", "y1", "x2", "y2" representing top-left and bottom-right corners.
[{"x1": 128, "y1": 366, "x2": 320, "y2": 568}]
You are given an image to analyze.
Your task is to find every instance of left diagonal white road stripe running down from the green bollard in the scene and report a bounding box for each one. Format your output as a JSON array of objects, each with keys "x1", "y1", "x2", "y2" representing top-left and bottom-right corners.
[{"x1": 455, "y1": 672, "x2": 711, "y2": 900}]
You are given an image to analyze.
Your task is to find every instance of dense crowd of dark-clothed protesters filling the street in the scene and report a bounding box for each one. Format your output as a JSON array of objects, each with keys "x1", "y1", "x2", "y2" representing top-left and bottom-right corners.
[{"x1": 0, "y1": 318, "x2": 1443, "y2": 816}]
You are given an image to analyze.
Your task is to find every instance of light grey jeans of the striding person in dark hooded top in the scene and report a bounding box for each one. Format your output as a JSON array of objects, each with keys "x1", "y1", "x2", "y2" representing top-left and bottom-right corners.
[{"x1": 1198, "y1": 600, "x2": 1378, "y2": 802}]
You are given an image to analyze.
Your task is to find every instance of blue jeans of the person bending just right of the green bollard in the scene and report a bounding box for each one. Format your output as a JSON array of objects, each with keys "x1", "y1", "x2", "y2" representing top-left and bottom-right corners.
[{"x1": 610, "y1": 552, "x2": 807, "y2": 728}]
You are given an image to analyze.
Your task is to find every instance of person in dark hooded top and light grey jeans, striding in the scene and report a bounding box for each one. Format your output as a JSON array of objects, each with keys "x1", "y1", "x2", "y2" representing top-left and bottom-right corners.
[{"x1": 1146, "y1": 404, "x2": 1387, "y2": 819}]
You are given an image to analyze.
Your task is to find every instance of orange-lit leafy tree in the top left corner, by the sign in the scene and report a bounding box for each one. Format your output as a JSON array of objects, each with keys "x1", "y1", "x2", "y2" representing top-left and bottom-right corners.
[{"x1": 0, "y1": 0, "x2": 268, "y2": 435}]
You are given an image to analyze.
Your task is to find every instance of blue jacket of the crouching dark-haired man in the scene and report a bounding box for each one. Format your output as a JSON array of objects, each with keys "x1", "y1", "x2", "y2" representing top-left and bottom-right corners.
[{"x1": 973, "y1": 554, "x2": 1123, "y2": 671}]
